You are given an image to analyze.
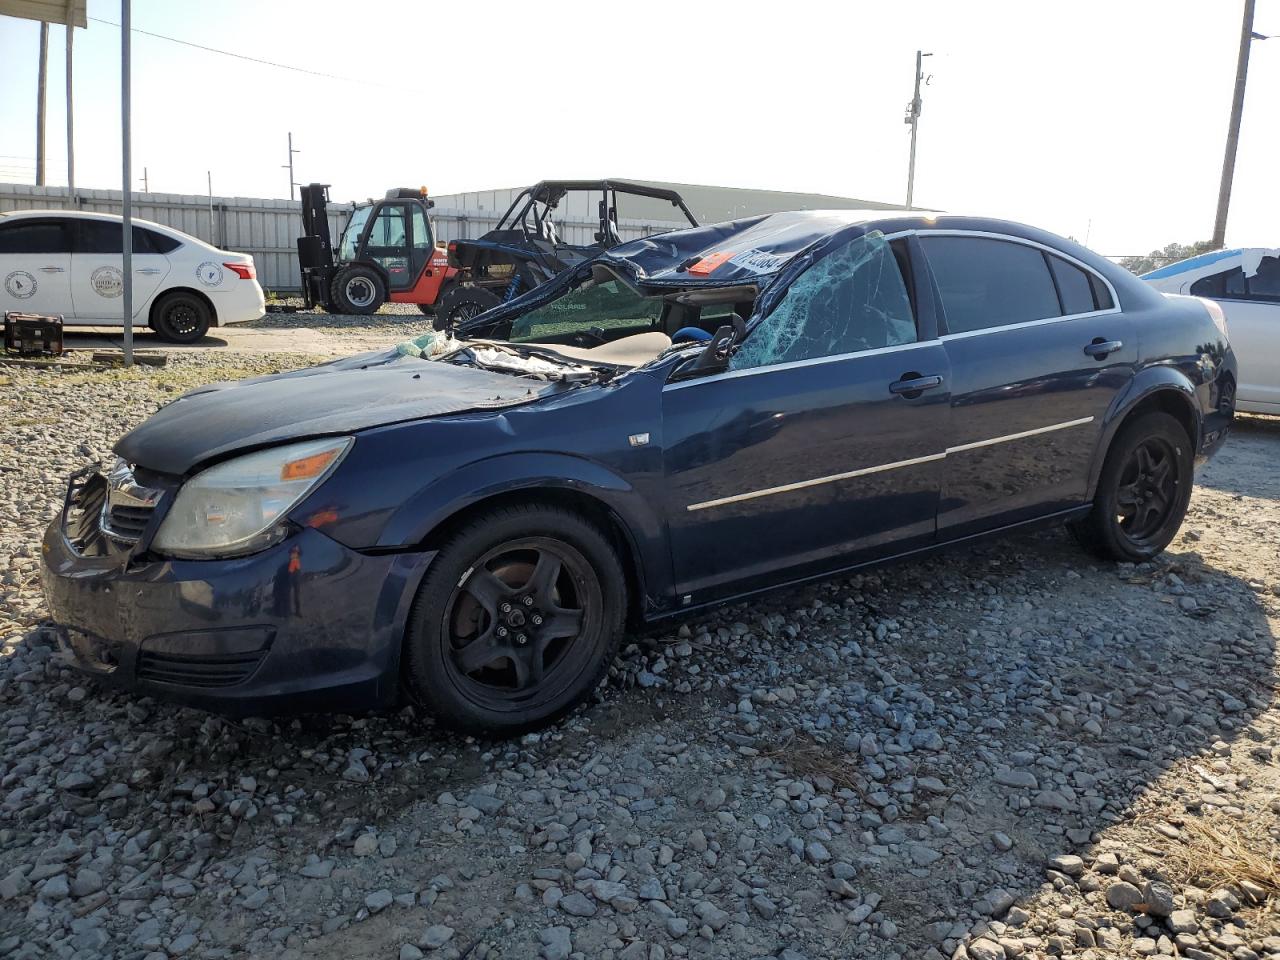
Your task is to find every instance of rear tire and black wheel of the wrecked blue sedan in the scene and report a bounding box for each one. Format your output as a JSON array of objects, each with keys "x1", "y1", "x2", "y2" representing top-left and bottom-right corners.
[{"x1": 1071, "y1": 412, "x2": 1194, "y2": 563}]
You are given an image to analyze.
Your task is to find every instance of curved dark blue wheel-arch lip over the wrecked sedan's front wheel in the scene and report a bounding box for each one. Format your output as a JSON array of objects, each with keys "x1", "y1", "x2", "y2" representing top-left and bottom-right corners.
[{"x1": 378, "y1": 452, "x2": 672, "y2": 596}]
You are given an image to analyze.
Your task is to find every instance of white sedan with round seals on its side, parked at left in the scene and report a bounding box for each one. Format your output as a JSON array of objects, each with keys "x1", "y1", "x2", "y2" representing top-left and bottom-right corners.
[{"x1": 0, "y1": 210, "x2": 264, "y2": 343}]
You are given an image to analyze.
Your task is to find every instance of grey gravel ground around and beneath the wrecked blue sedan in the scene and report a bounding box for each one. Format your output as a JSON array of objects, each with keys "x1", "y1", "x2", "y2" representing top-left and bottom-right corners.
[{"x1": 0, "y1": 352, "x2": 1280, "y2": 960}]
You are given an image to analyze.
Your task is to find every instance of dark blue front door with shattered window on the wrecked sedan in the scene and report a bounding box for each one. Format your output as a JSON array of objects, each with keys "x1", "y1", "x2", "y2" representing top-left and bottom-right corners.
[{"x1": 662, "y1": 234, "x2": 948, "y2": 603}]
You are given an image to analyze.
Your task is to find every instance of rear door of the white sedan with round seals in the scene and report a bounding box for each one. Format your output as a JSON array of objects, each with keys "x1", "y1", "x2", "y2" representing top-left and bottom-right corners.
[{"x1": 72, "y1": 219, "x2": 171, "y2": 324}]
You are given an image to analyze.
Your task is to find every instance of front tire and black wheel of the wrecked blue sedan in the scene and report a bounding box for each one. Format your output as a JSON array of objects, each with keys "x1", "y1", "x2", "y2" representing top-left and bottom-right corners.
[{"x1": 403, "y1": 506, "x2": 626, "y2": 736}]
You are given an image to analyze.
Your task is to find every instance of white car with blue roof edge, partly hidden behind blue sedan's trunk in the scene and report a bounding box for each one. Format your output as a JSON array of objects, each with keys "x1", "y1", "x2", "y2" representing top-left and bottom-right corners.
[{"x1": 1142, "y1": 247, "x2": 1280, "y2": 413}]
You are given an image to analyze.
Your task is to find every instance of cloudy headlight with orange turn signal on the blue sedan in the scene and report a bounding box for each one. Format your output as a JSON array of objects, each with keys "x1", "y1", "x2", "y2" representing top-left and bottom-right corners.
[{"x1": 151, "y1": 436, "x2": 352, "y2": 557}]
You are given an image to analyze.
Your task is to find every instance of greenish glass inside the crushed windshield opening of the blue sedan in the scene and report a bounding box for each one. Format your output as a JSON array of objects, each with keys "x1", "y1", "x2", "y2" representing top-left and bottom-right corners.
[{"x1": 507, "y1": 273, "x2": 662, "y2": 343}]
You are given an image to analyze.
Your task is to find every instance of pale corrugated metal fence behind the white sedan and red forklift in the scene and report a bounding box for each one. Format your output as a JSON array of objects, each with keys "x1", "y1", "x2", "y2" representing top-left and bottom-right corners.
[{"x1": 0, "y1": 183, "x2": 685, "y2": 291}]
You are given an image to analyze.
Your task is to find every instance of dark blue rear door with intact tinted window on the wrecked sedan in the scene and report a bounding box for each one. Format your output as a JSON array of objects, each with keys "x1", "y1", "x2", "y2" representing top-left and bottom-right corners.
[{"x1": 920, "y1": 232, "x2": 1138, "y2": 540}]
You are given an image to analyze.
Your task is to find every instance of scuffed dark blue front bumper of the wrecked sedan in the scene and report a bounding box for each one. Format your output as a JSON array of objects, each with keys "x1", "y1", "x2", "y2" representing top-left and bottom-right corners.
[{"x1": 42, "y1": 518, "x2": 434, "y2": 716}]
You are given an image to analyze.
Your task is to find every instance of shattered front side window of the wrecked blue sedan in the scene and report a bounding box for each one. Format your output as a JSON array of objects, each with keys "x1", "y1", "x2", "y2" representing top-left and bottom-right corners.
[{"x1": 730, "y1": 233, "x2": 916, "y2": 370}]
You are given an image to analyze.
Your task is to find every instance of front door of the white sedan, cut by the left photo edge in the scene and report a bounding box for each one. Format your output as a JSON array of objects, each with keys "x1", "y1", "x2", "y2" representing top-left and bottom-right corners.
[{"x1": 0, "y1": 216, "x2": 74, "y2": 320}]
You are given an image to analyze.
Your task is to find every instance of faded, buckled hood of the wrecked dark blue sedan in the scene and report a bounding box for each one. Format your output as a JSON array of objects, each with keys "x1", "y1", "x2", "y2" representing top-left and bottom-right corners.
[{"x1": 115, "y1": 351, "x2": 566, "y2": 475}]
